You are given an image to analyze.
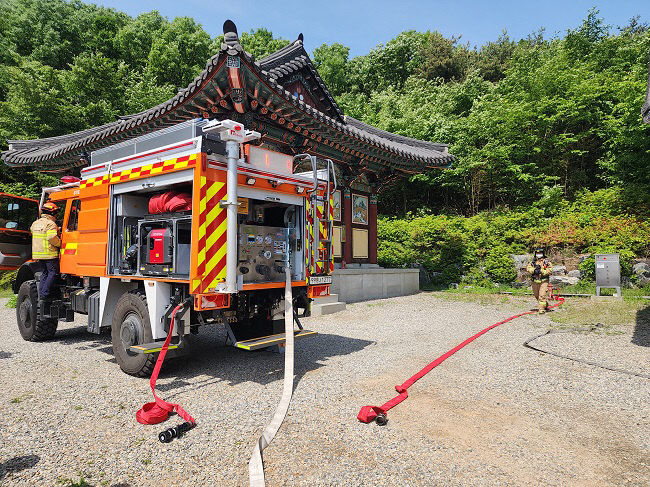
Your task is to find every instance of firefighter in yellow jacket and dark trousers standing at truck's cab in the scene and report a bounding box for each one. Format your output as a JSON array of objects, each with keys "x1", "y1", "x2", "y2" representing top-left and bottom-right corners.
[{"x1": 30, "y1": 201, "x2": 61, "y2": 299}]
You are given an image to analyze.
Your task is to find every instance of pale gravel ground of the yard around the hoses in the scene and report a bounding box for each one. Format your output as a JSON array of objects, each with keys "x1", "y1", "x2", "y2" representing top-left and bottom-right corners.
[{"x1": 0, "y1": 293, "x2": 650, "y2": 486}]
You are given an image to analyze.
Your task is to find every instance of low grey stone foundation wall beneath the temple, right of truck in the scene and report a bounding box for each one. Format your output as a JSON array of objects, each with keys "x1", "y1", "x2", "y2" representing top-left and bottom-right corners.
[{"x1": 330, "y1": 268, "x2": 420, "y2": 303}]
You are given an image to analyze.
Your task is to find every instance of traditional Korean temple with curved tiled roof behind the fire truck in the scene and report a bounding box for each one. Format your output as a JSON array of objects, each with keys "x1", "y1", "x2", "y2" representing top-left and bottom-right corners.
[{"x1": 2, "y1": 20, "x2": 454, "y2": 304}]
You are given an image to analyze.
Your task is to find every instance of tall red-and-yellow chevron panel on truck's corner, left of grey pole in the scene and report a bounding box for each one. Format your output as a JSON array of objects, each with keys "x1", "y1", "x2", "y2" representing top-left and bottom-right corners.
[{"x1": 191, "y1": 176, "x2": 228, "y2": 293}]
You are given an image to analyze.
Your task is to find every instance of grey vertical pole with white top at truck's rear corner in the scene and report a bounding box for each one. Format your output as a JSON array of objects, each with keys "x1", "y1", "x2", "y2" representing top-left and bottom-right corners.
[{"x1": 203, "y1": 120, "x2": 261, "y2": 293}]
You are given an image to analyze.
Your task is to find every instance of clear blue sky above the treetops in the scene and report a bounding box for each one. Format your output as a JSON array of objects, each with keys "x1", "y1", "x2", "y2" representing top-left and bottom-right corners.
[{"x1": 92, "y1": 0, "x2": 650, "y2": 56}]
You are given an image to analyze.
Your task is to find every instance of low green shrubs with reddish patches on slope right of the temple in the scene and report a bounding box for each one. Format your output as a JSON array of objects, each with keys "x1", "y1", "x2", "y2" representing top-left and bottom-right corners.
[{"x1": 378, "y1": 188, "x2": 650, "y2": 285}]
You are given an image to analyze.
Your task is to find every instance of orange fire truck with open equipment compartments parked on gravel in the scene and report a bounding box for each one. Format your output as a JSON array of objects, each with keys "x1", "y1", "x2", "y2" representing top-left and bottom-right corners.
[{"x1": 14, "y1": 119, "x2": 336, "y2": 377}]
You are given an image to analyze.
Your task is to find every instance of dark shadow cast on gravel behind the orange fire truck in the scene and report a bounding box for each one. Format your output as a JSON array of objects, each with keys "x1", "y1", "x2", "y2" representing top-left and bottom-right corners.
[{"x1": 156, "y1": 330, "x2": 373, "y2": 398}]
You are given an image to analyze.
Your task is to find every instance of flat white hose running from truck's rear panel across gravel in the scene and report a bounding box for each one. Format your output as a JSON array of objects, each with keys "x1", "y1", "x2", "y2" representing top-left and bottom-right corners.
[{"x1": 248, "y1": 266, "x2": 294, "y2": 487}]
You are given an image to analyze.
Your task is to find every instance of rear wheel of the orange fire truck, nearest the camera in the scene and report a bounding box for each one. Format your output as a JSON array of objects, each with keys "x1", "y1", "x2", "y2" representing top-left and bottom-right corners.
[{"x1": 111, "y1": 292, "x2": 158, "y2": 377}]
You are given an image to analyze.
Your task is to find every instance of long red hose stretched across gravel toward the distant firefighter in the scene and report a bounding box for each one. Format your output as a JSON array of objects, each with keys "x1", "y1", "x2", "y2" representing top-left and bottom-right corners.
[{"x1": 357, "y1": 288, "x2": 564, "y2": 424}]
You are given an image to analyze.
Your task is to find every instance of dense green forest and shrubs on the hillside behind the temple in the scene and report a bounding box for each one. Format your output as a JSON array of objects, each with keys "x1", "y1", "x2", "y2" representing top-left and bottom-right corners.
[{"x1": 0, "y1": 0, "x2": 650, "y2": 286}]
